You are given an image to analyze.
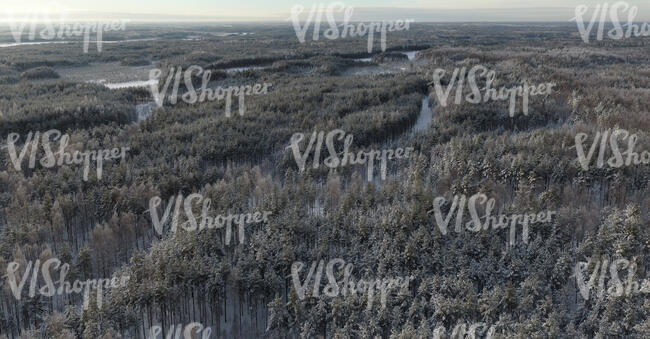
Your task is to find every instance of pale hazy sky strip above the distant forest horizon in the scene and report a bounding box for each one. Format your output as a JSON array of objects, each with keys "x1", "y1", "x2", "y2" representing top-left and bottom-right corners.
[{"x1": 0, "y1": 0, "x2": 650, "y2": 22}]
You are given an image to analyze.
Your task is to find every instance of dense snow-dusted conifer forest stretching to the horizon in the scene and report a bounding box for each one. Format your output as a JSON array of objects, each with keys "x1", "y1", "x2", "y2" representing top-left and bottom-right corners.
[{"x1": 0, "y1": 23, "x2": 650, "y2": 339}]
